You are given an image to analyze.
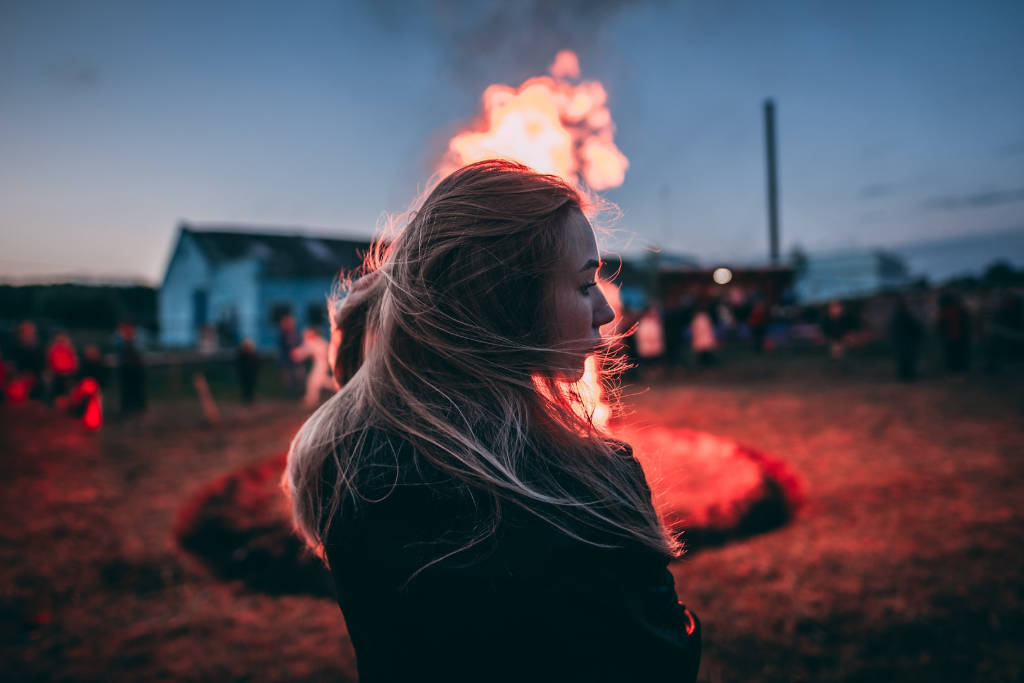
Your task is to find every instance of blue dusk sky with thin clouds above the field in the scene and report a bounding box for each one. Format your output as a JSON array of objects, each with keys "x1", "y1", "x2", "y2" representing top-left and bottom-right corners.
[{"x1": 0, "y1": 0, "x2": 1024, "y2": 283}]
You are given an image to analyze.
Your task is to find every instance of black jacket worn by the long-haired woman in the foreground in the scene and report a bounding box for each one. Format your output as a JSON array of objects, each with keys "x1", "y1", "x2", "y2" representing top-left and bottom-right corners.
[{"x1": 325, "y1": 439, "x2": 700, "y2": 683}]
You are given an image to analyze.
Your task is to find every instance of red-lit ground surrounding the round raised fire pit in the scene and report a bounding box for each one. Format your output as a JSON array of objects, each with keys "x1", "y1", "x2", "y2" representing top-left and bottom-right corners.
[{"x1": 0, "y1": 353, "x2": 1024, "y2": 682}]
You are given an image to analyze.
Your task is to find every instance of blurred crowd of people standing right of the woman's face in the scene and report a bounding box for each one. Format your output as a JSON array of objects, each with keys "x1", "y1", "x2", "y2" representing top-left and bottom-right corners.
[{"x1": 617, "y1": 290, "x2": 1024, "y2": 381}]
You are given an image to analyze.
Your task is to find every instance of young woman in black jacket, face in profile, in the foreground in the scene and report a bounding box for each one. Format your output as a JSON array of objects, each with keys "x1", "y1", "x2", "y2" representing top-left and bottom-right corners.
[{"x1": 285, "y1": 161, "x2": 700, "y2": 683}]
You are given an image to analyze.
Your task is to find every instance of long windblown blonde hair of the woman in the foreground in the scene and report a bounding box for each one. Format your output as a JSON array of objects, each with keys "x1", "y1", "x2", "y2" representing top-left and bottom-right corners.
[{"x1": 284, "y1": 160, "x2": 679, "y2": 556}]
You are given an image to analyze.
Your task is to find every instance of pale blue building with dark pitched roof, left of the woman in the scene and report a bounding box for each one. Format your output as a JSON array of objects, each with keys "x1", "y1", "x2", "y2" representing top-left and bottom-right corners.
[{"x1": 158, "y1": 223, "x2": 370, "y2": 349}]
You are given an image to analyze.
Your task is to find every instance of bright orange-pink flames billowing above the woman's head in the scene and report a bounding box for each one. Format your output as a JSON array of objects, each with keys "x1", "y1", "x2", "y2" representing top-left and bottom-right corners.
[{"x1": 438, "y1": 50, "x2": 630, "y2": 190}]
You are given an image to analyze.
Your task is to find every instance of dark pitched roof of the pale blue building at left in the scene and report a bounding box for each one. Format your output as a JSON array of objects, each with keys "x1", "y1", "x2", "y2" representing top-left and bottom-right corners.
[{"x1": 181, "y1": 223, "x2": 370, "y2": 279}]
